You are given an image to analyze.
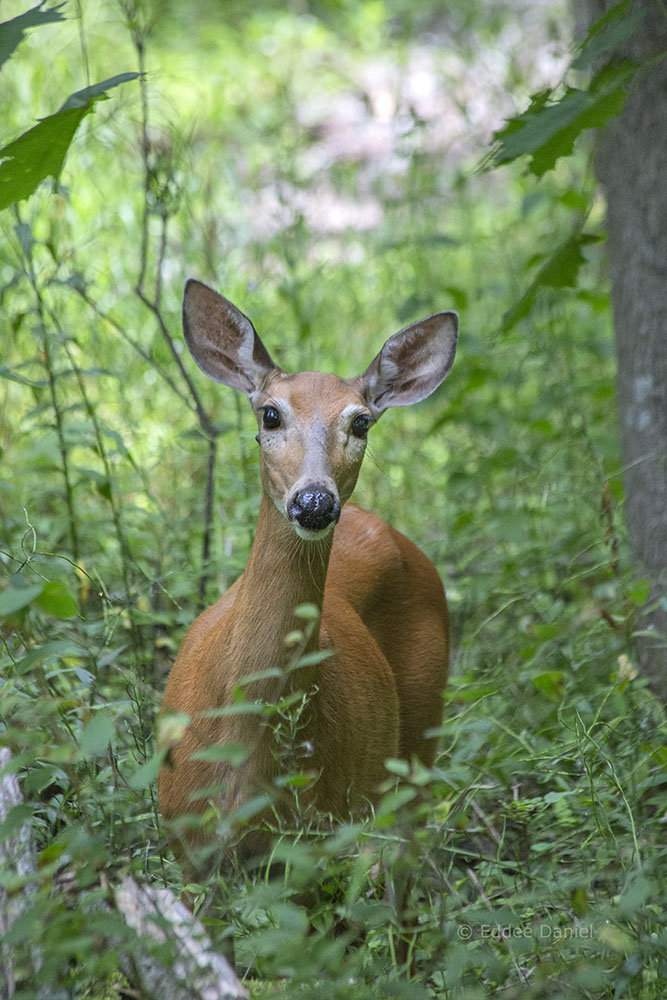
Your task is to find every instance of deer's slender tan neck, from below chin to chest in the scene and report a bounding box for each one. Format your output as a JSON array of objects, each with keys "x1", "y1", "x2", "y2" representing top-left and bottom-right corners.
[{"x1": 226, "y1": 496, "x2": 333, "y2": 701}]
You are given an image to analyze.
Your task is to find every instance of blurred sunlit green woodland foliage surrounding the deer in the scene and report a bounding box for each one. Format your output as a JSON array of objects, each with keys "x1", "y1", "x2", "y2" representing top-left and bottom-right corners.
[{"x1": 0, "y1": 0, "x2": 667, "y2": 998}]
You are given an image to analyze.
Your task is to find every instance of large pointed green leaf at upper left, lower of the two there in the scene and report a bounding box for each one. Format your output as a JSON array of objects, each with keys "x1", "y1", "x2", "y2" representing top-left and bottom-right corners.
[{"x1": 0, "y1": 73, "x2": 140, "y2": 210}]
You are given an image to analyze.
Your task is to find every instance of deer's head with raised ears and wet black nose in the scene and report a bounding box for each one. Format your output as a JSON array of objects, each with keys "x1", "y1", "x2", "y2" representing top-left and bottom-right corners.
[{"x1": 183, "y1": 278, "x2": 458, "y2": 540}]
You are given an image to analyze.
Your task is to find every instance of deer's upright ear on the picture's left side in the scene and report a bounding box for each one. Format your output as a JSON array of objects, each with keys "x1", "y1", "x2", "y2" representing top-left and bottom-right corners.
[{"x1": 183, "y1": 278, "x2": 276, "y2": 396}]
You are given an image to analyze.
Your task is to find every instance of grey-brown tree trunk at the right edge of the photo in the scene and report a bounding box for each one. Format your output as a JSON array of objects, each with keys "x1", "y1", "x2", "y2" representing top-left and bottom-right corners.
[{"x1": 577, "y1": 0, "x2": 667, "y2": 701}]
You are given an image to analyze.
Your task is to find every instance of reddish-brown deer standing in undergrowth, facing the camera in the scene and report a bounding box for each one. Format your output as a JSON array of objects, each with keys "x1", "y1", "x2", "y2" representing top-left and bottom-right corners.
[{"x1": 159, "y1": 279, "x2": 458, "y2": 863}]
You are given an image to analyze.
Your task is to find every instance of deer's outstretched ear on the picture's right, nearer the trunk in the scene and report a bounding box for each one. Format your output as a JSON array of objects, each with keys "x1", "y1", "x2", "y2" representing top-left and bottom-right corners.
[{"x1": 361, "y1": 312, "x2": 459, "y2": 416}]
